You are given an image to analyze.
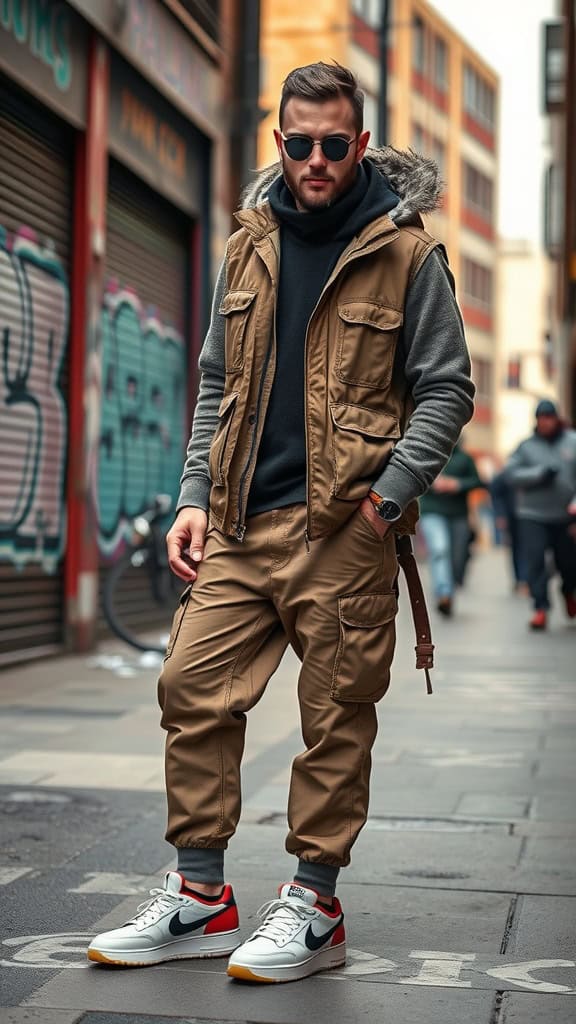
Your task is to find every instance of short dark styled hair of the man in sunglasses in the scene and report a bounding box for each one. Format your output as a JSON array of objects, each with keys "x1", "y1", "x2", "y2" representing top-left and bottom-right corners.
[{"x1": 279, "y1": 60, "x2": 364, "y2": 135}]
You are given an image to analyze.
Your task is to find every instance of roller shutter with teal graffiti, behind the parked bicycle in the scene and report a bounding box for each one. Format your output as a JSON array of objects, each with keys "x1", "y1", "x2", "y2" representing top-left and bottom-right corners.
[{"x1": 98, "y1": 161, "x2": 190, "y2": 631}]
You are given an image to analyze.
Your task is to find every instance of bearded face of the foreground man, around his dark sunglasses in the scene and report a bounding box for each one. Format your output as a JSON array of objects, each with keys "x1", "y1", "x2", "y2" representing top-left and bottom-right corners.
[{"x1": 274, "y1": 96, "x2": 370, "y2": 212}]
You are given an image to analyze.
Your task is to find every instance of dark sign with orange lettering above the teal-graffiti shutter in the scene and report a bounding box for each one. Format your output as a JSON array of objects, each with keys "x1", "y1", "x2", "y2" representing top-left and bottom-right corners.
[{"x1": 110, "y1": 54, "x2": 202, "y2": 213}]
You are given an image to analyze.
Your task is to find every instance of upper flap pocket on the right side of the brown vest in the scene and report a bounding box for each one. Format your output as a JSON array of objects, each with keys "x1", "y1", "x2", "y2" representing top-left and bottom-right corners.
[{"x1": 336, "y1": 299, "x2": 404, "y2": 388}]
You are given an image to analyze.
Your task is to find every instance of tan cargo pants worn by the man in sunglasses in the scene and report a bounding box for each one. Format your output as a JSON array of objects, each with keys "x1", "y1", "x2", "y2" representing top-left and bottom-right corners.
[{"x1": 159, "y1": 505, "x2": 398, "y2": 866}]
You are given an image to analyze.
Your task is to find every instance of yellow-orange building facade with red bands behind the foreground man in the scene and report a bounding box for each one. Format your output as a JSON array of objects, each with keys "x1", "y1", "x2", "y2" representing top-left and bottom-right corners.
[{"x1": 258, "y1": 0, "x2": 498, "y2": 460}]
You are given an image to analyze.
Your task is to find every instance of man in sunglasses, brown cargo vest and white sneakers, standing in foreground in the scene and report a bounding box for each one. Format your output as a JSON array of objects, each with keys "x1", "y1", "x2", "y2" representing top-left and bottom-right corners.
[{"x1": 88, "y1": 63, "x2": 474, "y2": 981}]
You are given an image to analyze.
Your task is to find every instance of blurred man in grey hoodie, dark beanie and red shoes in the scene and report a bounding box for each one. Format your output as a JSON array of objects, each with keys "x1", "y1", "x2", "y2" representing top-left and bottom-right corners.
[{"x1": 505, "y1": 399, "x2": 576, "y2": 630}]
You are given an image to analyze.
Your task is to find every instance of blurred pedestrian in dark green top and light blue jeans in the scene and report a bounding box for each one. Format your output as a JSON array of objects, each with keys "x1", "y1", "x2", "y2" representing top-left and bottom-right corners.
[{"x1": 420, "y1": 441, "x2": 484, "y2": 616}]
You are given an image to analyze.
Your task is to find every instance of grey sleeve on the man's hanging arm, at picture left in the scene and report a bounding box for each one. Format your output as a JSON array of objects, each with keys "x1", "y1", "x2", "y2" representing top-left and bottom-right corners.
[{"x1": 176, "y1": 263, "x2": 225, "y2": 511}]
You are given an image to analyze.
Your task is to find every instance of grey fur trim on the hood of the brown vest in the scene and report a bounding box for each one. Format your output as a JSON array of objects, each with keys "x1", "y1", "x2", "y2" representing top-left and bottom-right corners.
[{"x1": 241, "y1": 145, "x2": 444, "y2": 225}]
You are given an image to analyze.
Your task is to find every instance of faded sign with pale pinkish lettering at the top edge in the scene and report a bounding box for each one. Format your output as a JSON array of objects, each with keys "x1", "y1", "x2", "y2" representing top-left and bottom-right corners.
[{"x1": 63, "y1": 0, "x2": 221, "y2": 135}]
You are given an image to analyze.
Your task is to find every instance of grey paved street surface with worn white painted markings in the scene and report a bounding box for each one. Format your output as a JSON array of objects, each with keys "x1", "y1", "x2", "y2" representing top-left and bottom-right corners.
[{"x1": 0, "y1": 551, "x2": 576, "y2": 1024}]
